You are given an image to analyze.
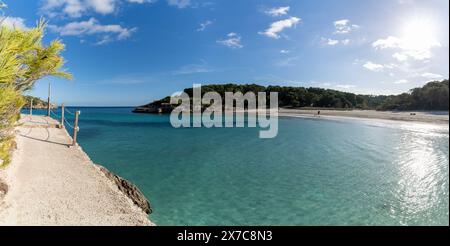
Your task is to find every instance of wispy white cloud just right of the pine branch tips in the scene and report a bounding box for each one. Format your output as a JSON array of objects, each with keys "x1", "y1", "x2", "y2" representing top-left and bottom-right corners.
[{"x1": 48, "y1": 18, "x2": 137, "y2": 45}]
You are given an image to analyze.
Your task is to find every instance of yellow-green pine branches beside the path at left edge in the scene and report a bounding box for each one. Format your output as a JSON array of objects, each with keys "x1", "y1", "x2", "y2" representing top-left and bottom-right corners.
[{"x1": 0, "y1": 11, "x2": 71, "y2": 166}]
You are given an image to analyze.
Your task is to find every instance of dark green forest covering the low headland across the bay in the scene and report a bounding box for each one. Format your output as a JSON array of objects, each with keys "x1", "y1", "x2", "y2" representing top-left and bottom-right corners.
[{"x1": 137, "y1": 80, "x2": 449, "y2": 112}]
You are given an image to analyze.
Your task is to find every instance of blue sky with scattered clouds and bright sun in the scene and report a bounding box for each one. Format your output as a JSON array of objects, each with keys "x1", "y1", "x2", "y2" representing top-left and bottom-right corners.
[{"x1": 2, "y1": 0, "x2": 449, "y2": 106}]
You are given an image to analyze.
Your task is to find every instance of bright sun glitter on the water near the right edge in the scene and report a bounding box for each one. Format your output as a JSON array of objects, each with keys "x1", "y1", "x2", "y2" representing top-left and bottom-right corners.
[{"x1": 391, "y1": 124, "x2": 449, "y2": 224}]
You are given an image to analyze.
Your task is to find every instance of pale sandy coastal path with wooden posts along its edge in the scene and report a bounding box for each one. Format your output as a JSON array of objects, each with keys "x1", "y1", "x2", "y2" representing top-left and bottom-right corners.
[{"x1": 0, "y1": 116, "x2": 151, "y2": 225}]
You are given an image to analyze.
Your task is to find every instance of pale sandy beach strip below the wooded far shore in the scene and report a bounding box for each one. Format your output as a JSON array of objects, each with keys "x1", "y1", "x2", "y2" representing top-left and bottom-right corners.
[{"x1": 279, "y1": 108, "x2": 449, "y2": 124}]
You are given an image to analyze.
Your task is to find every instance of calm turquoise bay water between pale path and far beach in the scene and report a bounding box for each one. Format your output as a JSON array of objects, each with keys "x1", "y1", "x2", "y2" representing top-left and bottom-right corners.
[{"x1": 29, "y1": 108, "x2": 449, "y2": 225}]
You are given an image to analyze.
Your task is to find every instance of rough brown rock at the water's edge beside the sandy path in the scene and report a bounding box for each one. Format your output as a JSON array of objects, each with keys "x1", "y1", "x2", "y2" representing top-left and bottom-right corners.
[{"x1": 96, "y1": 165, "x2": 152, "y2": 214}]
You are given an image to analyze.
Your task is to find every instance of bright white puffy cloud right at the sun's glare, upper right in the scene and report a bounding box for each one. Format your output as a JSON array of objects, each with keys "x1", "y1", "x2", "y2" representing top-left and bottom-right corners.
[{"x1": 372, "y1": 36, "x2": 441, "y2": 61}]
